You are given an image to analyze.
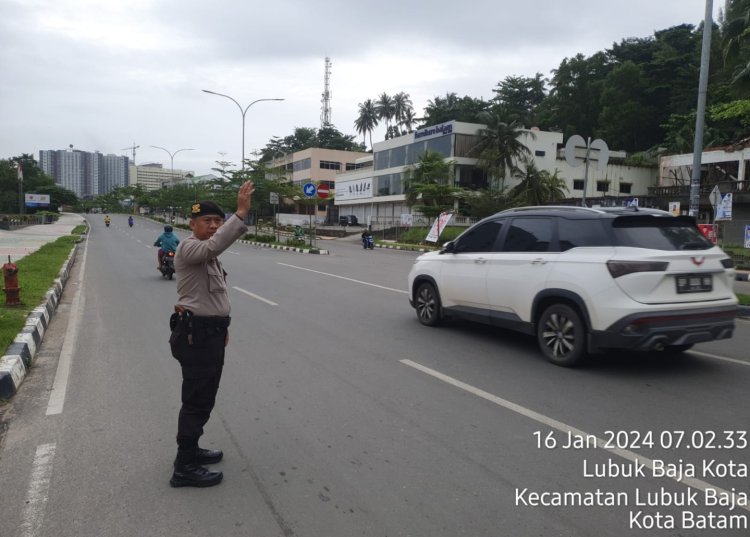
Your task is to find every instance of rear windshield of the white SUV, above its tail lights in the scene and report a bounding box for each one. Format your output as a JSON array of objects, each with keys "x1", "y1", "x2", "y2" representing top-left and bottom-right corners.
[{"x1": 612, "y1": 216, "x2": 713, "y2": 250}]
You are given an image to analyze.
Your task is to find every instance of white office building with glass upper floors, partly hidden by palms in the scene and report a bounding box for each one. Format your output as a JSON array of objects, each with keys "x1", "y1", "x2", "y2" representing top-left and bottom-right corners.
[{"x1": 334, "y1": 121, "x2": 658, "y2": 223}]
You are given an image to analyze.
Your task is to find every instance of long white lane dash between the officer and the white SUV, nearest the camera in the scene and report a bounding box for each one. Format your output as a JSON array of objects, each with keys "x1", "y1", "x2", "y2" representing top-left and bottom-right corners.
[{"x1": 399, "y1": 360, "x2": 750, "y2": 511}]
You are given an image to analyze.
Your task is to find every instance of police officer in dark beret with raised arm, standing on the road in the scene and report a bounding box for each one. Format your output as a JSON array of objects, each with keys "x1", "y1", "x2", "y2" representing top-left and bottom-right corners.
[{"x1": 169, "y1": 181, "x2": 255, "y2": 487}]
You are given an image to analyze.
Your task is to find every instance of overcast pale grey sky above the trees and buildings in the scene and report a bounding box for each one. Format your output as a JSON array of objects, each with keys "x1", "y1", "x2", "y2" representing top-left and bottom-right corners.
[{"x1": 0, "y1": 0, "x2": 724, "y2": 175}]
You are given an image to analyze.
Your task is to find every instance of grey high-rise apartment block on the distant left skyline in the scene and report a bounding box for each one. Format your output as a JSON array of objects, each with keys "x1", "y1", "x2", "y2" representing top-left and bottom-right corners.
[{"x1": 39, "y1": 148, "x2": 130, "y2": 198}]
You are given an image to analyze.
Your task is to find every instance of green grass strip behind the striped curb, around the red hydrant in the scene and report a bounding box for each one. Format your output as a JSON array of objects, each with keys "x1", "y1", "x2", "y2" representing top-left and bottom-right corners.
[{"x1": 0, "y1": 234, "x2": 80, "y2": 356}]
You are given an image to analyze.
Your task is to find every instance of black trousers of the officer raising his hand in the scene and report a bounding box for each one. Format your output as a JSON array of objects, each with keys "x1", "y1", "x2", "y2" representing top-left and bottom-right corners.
[{"x1": 170, "y1": 320, "x2": 227, "y2": 462}]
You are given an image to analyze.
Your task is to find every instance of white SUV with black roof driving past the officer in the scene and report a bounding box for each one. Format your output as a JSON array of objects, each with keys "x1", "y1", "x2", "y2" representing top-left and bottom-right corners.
[{"x1": 408, "y1": 207, "x2": 737, "y2": 366}]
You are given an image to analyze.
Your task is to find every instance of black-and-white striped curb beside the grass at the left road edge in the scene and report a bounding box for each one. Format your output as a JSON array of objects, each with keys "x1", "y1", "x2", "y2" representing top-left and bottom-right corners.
[{"x1": 0, "y1": 244, "x2": 78, "y2": 399}]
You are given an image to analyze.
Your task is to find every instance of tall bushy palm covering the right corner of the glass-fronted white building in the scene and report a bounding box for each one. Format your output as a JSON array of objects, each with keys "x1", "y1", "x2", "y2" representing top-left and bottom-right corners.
[{"x1": 472, "y1": 112, "x2": 536, "y2": 190}]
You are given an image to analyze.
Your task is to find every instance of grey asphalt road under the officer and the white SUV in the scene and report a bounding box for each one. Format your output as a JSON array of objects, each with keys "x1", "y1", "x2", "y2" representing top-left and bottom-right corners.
[{"x1": 0, "y1": 215, "x2": 750, "y2": 537}]
